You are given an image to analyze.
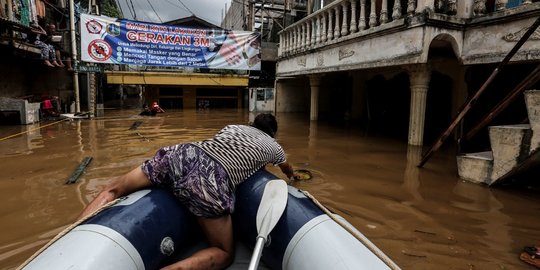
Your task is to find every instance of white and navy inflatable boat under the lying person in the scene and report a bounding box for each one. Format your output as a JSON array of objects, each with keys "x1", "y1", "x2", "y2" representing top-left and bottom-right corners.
[{"x1": 20, "y1": 170, "x2": 399, "y2": 270}]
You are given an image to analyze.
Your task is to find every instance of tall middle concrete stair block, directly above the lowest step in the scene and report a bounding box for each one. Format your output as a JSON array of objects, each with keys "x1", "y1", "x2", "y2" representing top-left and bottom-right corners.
[{"x1": 487, "y1": 124, "x2": 532, "y2": 185}]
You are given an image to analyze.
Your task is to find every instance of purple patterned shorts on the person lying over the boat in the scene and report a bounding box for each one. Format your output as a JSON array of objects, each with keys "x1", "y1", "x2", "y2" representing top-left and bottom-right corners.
[{"x1": 141, "y1": 144, "x2": 235, "y2": 218}]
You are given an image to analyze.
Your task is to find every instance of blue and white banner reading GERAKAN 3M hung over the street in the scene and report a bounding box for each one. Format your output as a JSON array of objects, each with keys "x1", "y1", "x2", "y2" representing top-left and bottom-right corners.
[{"x1": 81, "y1": 14, "x2": 261, "y2": 70}]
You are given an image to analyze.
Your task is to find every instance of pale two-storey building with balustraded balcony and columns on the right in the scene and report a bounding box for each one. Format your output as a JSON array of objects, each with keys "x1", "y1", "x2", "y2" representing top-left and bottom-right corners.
[{"x1": 276, "y1": 0, "x2": 540, "y2": 149}]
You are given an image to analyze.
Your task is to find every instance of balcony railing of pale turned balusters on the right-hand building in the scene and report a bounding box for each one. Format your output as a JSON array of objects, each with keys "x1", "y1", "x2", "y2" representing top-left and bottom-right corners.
[{"x1": 279, "y1": 0, "x2": 532, "y2": 57}]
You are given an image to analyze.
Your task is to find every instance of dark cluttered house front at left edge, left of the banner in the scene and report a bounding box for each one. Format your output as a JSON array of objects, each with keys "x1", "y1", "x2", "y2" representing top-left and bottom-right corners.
[{"x1": 0, "y1": 0, "x2": 74, "y2": 124}]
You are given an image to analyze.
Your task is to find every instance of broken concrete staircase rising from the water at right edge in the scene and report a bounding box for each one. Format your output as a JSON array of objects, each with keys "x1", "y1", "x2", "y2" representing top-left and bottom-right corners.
[{"x1": 457, "y1": 90, "x2": 540, "y2": 186}]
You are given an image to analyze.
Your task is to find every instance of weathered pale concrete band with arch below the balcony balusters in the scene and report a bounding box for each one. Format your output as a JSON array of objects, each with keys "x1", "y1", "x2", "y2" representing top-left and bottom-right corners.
[{"x1": 277, "y1": 1, "x2": 540, "y2": 76}]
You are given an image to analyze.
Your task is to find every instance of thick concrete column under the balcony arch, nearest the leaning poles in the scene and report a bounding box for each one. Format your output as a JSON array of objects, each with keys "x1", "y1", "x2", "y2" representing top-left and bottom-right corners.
[{"x1": 407, "y1": 64, "x2": 431, "y2": 145}]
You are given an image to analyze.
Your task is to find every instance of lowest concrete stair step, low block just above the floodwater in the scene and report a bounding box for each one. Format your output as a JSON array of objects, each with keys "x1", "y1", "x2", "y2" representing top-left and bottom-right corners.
[{"x1": 457, "y1": 151, "x2": 493, "y2": 184}]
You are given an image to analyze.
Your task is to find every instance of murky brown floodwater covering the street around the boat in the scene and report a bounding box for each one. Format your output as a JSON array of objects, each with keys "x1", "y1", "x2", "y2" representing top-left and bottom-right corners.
[{"x1": 0, "y1": 110, "x2": 540, "y2": 269}]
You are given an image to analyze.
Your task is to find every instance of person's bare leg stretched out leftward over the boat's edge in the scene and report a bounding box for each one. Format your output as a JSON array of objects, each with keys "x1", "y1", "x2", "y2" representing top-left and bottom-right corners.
[{"x1": 77, "y1": 167, "x2": 152, "y2": 219}]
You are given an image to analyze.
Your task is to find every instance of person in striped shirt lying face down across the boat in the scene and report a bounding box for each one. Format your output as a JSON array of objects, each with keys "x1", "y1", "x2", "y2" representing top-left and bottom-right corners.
[{"x1": 79, "y1": 114, "x2": 302, "y2": 269}]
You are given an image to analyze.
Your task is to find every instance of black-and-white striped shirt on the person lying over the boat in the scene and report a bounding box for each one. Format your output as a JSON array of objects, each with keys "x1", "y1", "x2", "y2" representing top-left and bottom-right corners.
[{"x1": 193, "y1": 125, "x2": 285, "y2": 186}]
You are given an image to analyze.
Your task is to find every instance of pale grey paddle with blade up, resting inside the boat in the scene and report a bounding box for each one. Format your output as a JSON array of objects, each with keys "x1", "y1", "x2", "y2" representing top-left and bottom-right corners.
[{"x1": 248, "y1": 179, "x2": 289, "y2": 270}]
